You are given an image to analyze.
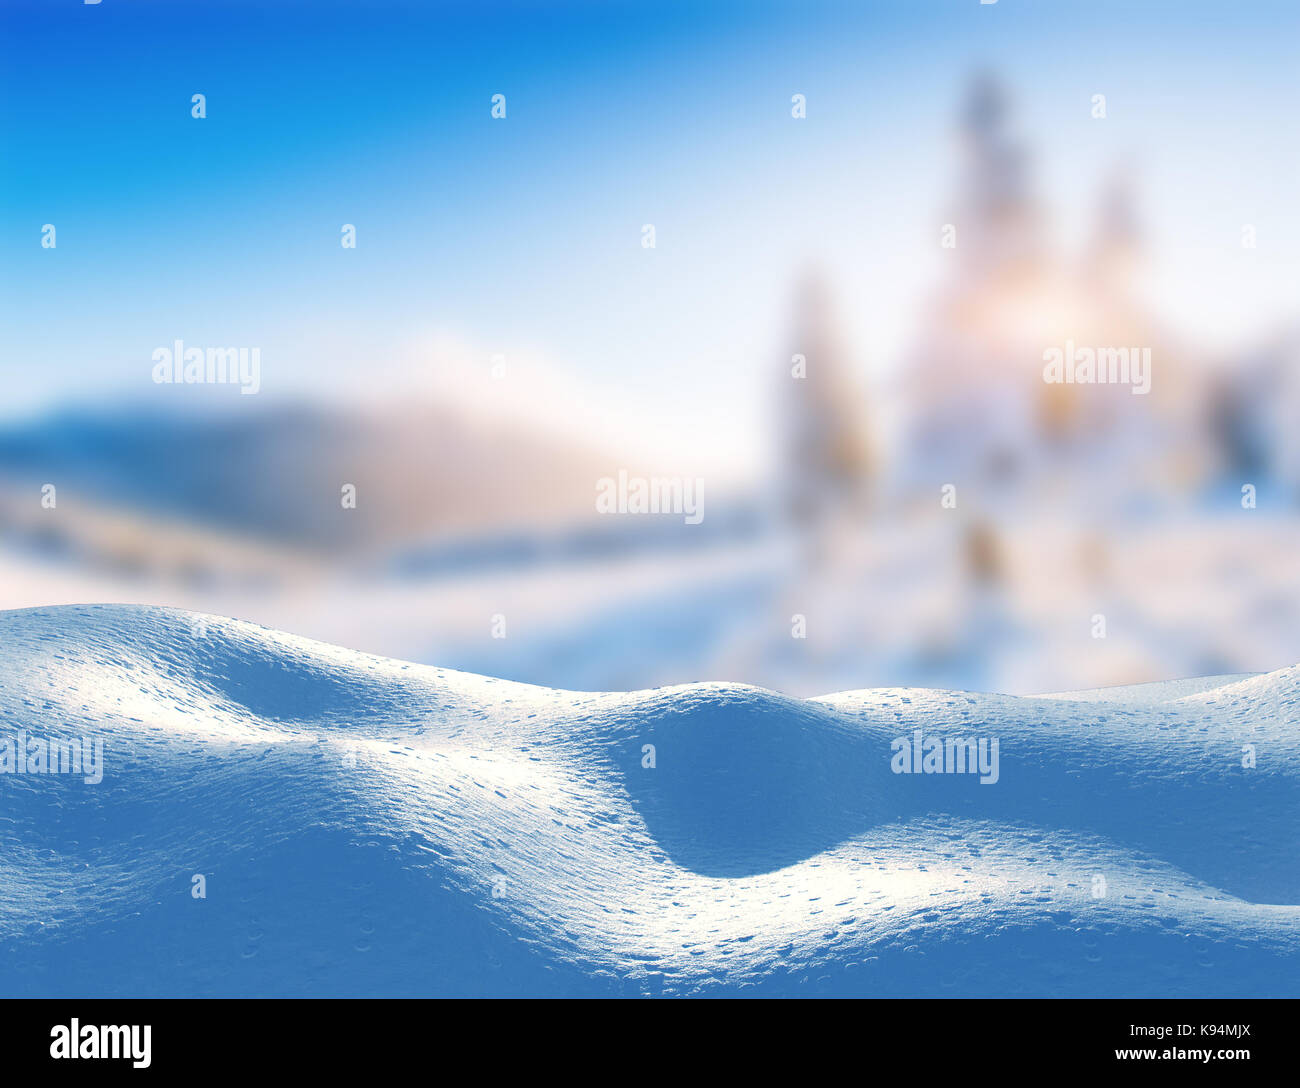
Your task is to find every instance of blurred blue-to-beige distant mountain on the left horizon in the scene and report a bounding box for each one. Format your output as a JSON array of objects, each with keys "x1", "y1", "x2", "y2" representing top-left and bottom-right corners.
[{"x1": 0, "y1": 404, "x2": 610, "y2": 569}]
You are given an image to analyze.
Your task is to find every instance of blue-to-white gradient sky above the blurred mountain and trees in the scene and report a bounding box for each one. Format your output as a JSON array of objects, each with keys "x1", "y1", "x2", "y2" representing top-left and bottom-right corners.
[{"x1": 0, "y1": 0, "x2": 1300, "y2": 469}]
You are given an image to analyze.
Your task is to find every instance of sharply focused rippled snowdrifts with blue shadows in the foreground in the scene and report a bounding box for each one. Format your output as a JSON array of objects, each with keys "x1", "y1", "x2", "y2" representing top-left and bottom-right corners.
[{"x1": 0, "y1": 606, "x2": 1300, "y2": 996}]
